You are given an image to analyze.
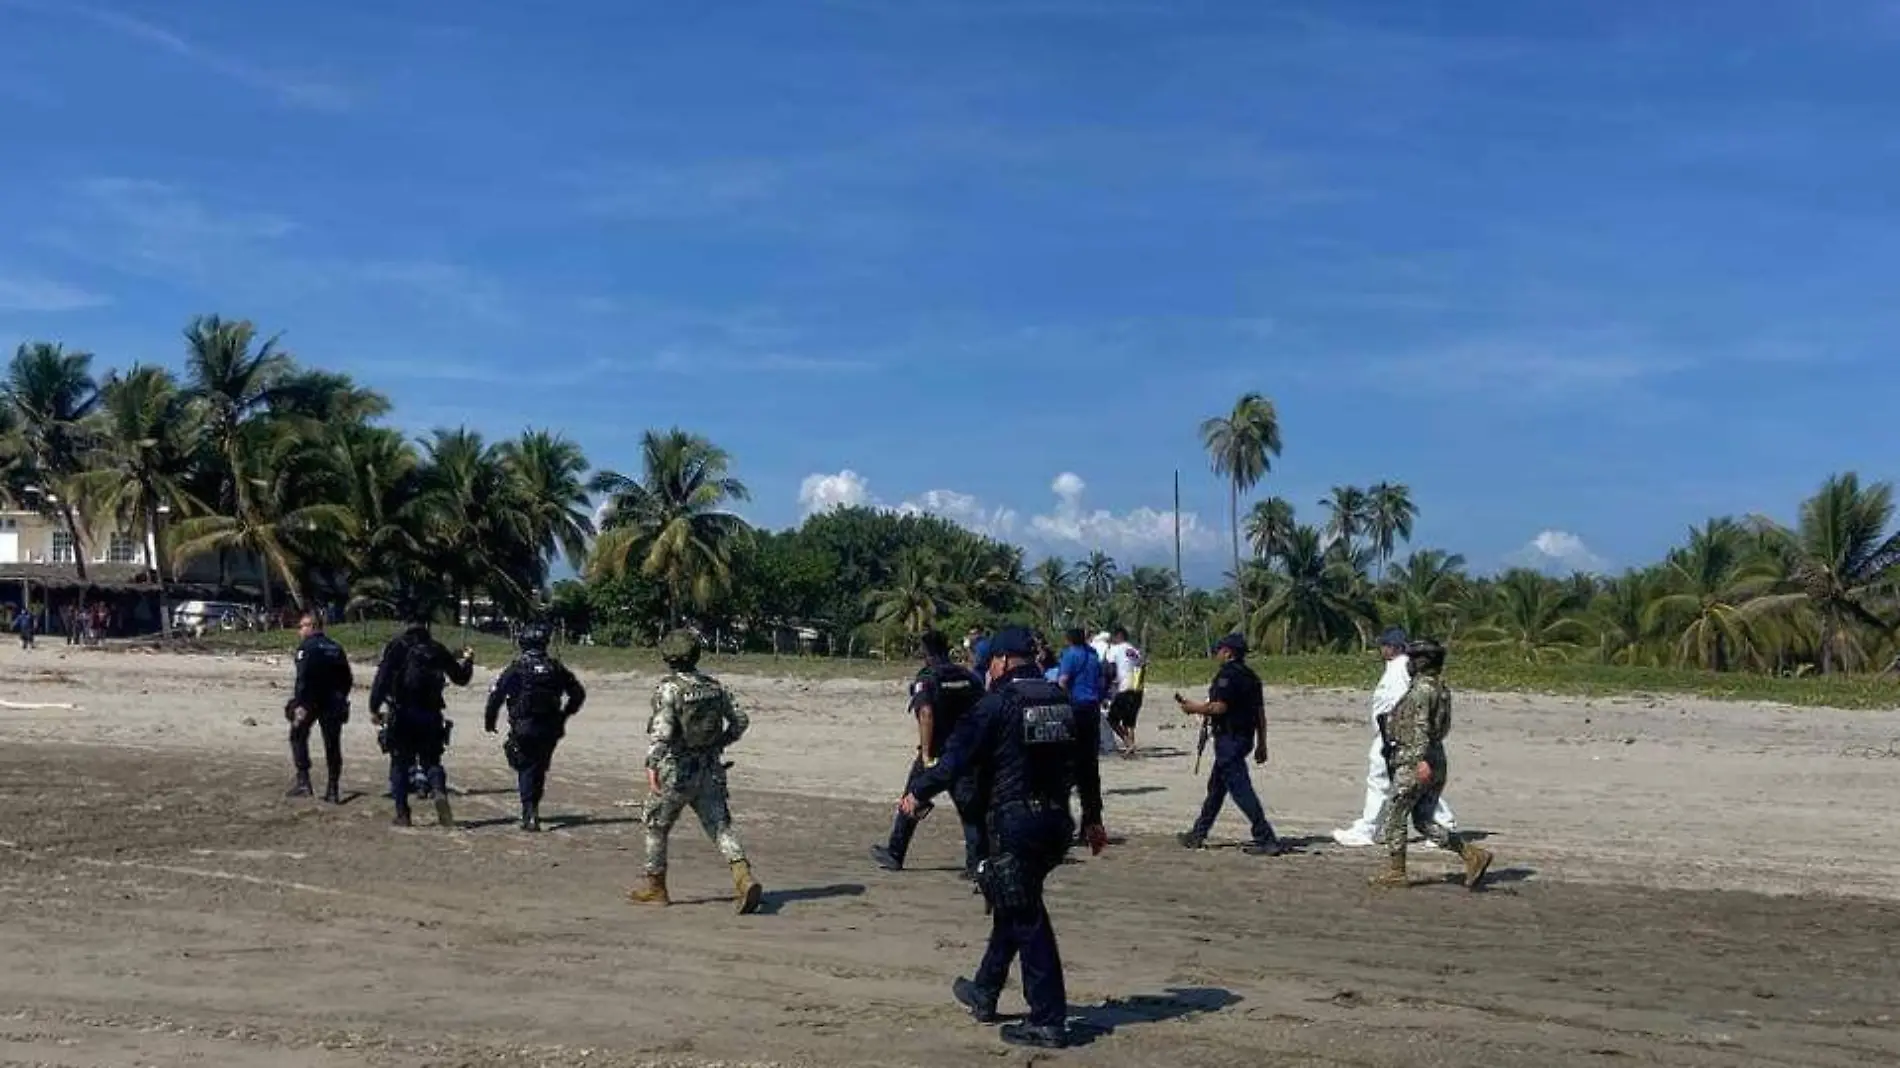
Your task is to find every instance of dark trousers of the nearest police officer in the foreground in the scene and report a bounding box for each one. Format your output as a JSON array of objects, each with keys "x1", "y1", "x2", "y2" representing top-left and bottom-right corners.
[{"x1": 975, "y1": 806, "x2": 1075, "y2": 1028}]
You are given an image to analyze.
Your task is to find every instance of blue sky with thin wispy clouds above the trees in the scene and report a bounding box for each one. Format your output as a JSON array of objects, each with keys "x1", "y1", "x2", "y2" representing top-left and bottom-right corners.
[{"x1": 0, "y1": 0, "x2": 1900, "y2": 578}]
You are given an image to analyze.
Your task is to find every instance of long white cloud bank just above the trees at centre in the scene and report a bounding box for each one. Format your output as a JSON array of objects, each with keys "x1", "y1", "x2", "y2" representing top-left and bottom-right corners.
[{"x1": 798, "y1": 467, "x2": 1220, "y2": 559}]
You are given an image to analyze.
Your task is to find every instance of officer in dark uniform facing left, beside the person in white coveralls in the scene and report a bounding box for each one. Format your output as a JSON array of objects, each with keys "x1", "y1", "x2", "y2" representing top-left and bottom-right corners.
[{"x1": 1174, "y1": 635, "x2": 1281, "y2": 857}]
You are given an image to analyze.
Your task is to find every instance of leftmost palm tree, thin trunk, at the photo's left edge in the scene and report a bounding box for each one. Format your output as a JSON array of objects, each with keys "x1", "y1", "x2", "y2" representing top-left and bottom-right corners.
[{"x1": 6, "y1": 342, "x2": 99, "y2": 582}]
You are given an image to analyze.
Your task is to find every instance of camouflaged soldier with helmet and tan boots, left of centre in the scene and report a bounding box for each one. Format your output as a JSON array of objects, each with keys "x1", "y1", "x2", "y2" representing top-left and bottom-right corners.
[{"x1": 627, "y1": 631, "x2": 764, "y2": 912}]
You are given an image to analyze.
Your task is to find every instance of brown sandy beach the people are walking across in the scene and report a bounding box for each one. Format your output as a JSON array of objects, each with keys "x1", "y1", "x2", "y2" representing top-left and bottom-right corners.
[{"x1": 0, "y1": 650, "x2": 1900, "y2": 1068}]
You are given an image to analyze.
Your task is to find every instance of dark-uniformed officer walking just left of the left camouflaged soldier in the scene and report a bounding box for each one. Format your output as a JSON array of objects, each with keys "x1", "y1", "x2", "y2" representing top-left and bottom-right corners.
[{"x1": 483, "y1": 623, "x2": 587, "y2": 830}]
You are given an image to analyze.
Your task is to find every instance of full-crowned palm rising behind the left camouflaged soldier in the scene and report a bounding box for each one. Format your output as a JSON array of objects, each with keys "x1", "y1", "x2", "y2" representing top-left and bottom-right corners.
[{"x1": 587, "y1": 428, "x2": 751, "y2": 620}]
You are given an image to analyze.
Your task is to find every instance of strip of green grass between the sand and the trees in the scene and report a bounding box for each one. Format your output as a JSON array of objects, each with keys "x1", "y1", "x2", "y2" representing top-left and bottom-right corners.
[{"x1": 178, "y1": 623, "x2": 1900, "y2": 709}]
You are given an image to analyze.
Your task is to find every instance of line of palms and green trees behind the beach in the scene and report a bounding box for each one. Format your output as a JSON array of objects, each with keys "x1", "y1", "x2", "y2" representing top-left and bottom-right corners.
[{"x1": 0, "y1": 315, "x2": 1900, "y2": 673}]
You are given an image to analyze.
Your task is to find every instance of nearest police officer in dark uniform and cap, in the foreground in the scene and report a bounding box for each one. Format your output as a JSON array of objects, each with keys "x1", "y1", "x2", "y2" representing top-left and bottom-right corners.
[{"x1": 899, "y1": 627, "x2": 1108, "y2": 1049}]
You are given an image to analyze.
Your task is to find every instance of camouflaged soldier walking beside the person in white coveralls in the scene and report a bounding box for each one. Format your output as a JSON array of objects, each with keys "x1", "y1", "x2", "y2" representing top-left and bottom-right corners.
[{"x1": 1372, "y1": 640, "x2": 1492, "y2": 889}]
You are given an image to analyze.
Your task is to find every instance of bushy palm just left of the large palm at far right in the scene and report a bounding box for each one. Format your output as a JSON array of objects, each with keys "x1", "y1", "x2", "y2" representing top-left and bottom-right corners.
[{"x1": 1647, "y1": 519, "x2": 1775, "y2": 671}]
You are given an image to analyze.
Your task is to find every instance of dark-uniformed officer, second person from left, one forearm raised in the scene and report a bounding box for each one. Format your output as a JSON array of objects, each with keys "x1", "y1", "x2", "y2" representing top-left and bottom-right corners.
[{"x1": 369, "y1": 612, "x2": 475, "y2": 827}]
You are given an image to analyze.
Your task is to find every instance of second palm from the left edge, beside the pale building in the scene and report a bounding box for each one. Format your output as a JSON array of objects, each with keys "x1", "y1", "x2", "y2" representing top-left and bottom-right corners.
[{"x1": 72, "y1": 365, "x2": 205, "y2": 611}]
